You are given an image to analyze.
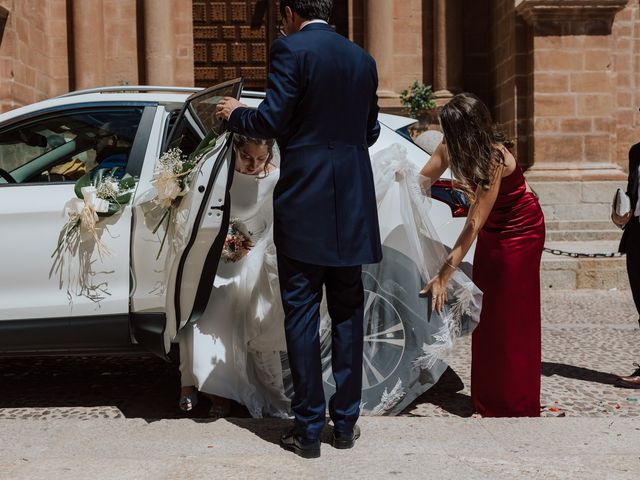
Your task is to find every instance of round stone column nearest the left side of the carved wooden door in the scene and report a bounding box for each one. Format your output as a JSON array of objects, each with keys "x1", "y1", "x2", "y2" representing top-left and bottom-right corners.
[{"x1": 144, "y1": 0, "x2": 175, "y2": 85}]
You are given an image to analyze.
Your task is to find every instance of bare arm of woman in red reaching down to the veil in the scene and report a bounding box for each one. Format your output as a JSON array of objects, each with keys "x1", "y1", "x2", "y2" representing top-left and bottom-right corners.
[{"x1": 420, "y1": 161, "x2": 504, "y2": 312}]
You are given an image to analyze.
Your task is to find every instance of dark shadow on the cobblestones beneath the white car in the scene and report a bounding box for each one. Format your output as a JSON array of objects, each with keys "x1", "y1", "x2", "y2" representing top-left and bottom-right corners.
[{"x1": 0, "y1": 356, "x2": 198, "y2": 419}]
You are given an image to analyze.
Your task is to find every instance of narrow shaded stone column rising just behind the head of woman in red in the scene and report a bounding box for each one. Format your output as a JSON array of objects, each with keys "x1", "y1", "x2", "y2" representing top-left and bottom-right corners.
[{"x1": 433, "y1": 0, "x2": 464, "y2": 104}]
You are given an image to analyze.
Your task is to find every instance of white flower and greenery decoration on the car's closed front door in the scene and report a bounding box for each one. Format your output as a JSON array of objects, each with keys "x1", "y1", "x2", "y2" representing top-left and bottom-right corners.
[{"x1": 51, "y1": 167, "x2": 136, "y2": 258}]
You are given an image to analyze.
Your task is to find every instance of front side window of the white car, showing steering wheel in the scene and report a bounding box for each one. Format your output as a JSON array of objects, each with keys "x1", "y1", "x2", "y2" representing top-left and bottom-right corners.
[{"x1": 0, "y1": 106, "x2": 143, "y2": 184}]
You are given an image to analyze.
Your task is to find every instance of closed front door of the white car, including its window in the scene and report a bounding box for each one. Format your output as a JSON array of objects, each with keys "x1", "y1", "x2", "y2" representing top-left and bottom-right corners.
[{"x1": 0, "y1": 102, "x2": 155, "y2": 351}]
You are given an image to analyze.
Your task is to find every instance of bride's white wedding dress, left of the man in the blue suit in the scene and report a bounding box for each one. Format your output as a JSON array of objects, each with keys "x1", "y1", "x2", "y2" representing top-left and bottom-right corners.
[{"x1": 179, "y1": 170, "x2": 290, "y2": 417}]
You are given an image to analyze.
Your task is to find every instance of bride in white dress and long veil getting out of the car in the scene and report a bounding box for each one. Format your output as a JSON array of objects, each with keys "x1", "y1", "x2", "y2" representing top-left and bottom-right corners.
[{"x1": 179, "y1": 135, "x2": 482, "y2": 417}]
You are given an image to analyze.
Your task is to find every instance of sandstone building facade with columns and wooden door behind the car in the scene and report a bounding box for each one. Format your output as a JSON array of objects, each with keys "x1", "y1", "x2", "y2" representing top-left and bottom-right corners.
[{"x1": 0, "y1": 0, "x2": 640, "y2": 229}]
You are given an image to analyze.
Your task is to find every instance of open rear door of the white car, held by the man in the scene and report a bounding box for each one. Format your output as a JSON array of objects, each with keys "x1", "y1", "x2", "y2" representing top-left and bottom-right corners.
[{"x1": 132, "y1": 79, "x2": 242, "y2": 356}]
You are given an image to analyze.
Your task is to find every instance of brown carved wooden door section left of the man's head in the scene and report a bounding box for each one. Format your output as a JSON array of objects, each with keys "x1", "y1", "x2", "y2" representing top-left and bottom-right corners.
[{"x1": 193, "y1": 0, "x2": 270, "y2": 90}]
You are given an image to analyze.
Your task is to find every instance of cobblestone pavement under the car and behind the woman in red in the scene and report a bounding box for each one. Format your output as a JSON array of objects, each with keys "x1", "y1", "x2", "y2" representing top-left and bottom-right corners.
[{"x1": 0, "y1": 290, "x2": 640, "y2": 419}]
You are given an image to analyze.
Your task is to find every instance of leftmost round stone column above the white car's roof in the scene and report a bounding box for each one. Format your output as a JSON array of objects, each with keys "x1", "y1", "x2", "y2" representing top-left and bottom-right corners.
[{"x1": 73, "y1": 0, "x2": 105, "y2": 90}]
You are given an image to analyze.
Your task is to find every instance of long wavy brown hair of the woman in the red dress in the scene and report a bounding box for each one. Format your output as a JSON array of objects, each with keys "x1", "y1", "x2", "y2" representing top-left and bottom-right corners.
[{"x1": 440, "y1": 93, "x2": 513, "y2": 201}]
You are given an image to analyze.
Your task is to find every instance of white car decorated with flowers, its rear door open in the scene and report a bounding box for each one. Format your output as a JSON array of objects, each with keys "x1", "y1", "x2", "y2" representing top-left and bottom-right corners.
[{"x1": 0, "y1": 80, "x2": 466, "y2": 398}]
